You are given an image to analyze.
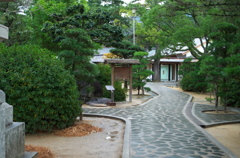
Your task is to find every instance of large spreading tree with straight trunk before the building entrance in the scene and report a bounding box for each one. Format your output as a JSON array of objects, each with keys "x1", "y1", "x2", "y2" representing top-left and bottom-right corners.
[{"x1": 141, "y1": 0, "x2": 238, "y2": 81}]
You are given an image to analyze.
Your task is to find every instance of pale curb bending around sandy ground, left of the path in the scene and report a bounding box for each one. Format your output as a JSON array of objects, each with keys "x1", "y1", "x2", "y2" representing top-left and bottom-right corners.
[{"x1": 83, "y1": 113, "x2": 131, "y2": 158}]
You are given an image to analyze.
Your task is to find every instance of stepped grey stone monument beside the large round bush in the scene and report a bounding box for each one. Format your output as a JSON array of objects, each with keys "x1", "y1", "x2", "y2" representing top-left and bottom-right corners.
[{"x1": 0, "y1": 90, "x2": 37, "y2": 158}]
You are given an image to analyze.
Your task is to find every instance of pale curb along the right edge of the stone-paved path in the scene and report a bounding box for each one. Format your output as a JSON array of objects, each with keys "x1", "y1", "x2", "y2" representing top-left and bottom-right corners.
[{"x1": 181, "y1": 92, "x2": 238, "y2": 158}]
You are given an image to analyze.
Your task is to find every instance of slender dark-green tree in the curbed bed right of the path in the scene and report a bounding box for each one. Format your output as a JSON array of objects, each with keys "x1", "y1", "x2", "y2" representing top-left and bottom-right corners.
[{"x1": 200, "y1": 22, "x2": 239, "y2": 111}]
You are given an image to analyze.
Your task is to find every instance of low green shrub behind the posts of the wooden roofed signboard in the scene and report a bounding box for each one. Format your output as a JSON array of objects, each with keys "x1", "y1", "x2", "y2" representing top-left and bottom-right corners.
[{"x1": 103, "y1": 81, "x2": 126, "y2": 101}]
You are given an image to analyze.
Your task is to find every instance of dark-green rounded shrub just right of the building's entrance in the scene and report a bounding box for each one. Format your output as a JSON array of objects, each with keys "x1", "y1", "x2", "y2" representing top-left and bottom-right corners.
[{"x1": 179, "y1": 58, "x2": 207, "y2": 92}]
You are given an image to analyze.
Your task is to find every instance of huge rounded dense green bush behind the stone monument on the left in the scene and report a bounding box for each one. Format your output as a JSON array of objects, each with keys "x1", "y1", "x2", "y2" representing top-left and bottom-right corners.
[{"x1": 0, "y1": 44, "x2": 81, "y2": 133}]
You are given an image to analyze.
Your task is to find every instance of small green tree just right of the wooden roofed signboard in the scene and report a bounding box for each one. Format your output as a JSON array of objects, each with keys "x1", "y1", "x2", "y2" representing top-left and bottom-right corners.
[{"x1": 132, "y1": 52, "x2": 153, "y2": 95}]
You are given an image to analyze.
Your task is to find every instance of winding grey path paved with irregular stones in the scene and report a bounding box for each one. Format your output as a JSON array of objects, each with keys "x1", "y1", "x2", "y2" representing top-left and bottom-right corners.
[{"x1": 84, "y1": 83, "x2": 228, "y2": 158}]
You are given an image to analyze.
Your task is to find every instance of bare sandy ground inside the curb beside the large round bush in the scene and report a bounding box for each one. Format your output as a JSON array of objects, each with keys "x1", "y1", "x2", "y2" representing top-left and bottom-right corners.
[{"x1": 25, "y1": 117, "x2": 125, "y2": 158}]
